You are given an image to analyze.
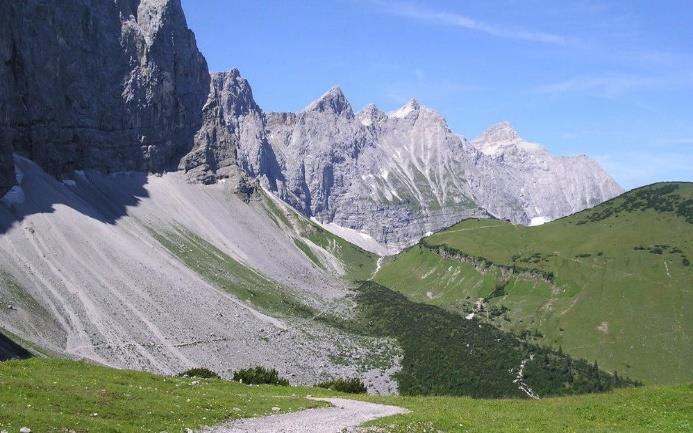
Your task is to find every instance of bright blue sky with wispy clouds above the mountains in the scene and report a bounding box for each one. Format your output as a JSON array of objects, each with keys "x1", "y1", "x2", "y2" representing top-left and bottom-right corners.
[{"x1": 182, "y1": 0, "x2": 693, "y2": 189}]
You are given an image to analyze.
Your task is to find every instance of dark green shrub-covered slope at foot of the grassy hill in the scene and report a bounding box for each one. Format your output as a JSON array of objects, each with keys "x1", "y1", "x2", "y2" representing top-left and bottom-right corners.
[{"x1": 348, "y1": 282, "x2": 635, "y2": 397}]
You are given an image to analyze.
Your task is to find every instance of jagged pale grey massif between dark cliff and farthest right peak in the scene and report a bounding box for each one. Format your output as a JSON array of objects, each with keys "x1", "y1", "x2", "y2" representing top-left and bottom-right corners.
[{"x1": 267, "y1": 88, "x2": 484, "y2": 248}]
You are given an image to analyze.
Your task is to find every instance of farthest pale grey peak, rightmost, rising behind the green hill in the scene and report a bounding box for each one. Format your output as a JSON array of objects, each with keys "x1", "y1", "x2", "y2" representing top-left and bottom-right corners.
[{"x1": 472, "y1": 122, "x2": 623, "y2": 224}]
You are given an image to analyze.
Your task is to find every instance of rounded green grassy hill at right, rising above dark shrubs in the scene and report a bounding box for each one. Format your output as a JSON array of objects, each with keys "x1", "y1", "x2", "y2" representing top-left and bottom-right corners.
[{"x1": 375, "y1": 183, "x2": 693, "y2": 383}]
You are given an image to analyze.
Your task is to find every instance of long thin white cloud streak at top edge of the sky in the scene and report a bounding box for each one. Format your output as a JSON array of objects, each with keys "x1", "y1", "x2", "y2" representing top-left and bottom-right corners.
[{"x1": 373, "y1": 0, "x2": 568, "y2": 45}]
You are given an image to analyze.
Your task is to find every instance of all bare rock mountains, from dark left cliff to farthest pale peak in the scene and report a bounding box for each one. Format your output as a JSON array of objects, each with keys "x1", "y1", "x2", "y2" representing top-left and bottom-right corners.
[{"x1": 0, "y1": 0, "x2": 622, "y2": 252}]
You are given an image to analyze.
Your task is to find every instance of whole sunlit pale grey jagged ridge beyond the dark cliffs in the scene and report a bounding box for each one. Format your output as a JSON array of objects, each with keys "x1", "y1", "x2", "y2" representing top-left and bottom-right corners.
[{"x1": 251, "y1": 88, "x2": 622, "y2": 249}]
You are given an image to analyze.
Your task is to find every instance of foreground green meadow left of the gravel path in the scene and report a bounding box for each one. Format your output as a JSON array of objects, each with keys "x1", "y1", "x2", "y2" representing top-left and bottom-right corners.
[{"x1": 0, "y1": 358, "x2": 323, "y2": 433}]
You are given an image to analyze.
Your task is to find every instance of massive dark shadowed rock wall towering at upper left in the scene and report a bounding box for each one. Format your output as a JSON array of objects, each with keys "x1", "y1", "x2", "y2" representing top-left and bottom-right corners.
[{"x1": 0, "y1": 0, "x2": 209, "y2": 195}]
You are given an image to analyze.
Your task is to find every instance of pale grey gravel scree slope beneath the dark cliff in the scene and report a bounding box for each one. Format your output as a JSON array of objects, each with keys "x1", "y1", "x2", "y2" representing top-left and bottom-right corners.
[{"x1": 0, "y1": 157, "x2": 400, "y2": 392}]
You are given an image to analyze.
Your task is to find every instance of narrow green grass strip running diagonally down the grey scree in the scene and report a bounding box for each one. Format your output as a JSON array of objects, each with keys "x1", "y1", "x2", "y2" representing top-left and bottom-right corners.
[{"x1": 150, "y1": 228, "x2": 315, "y2": 318}]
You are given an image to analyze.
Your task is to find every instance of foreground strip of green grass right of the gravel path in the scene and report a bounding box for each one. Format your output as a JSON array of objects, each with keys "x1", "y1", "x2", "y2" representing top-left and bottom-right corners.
[{"x1": 366, "y1": 385, "x2": 693, "y2": 433}]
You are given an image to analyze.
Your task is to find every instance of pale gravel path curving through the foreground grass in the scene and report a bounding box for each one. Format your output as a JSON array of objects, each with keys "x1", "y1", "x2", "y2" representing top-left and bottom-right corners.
[{"x1": 205, "y1": 398, "x2": 409, "y2": 433}]
